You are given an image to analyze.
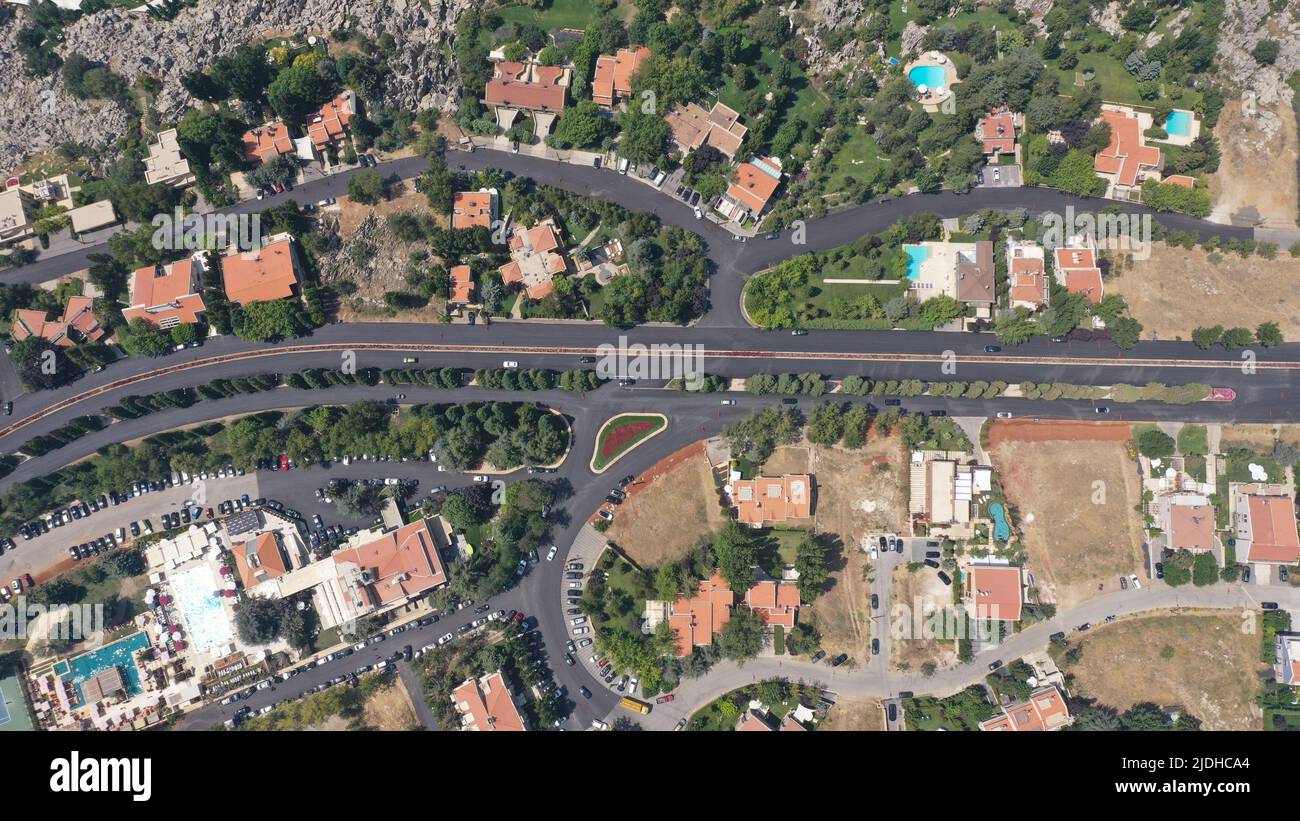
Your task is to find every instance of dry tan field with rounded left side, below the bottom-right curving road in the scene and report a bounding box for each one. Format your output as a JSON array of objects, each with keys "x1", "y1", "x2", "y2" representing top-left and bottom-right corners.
[{"x1": 1071, "y1": 613, "x2": 1262, "y2": 730}]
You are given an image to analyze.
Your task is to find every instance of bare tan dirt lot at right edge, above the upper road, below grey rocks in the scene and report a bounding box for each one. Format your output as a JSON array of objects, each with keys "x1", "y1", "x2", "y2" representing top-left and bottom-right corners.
[{"x1": 1206, "y1": 100, "x2": 1300, "y2": 229}]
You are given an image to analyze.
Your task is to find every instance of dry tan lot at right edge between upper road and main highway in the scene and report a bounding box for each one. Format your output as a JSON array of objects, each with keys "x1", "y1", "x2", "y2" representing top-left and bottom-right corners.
[{"x1": 1106, "y1": 240, "x2": 1300, "y2": 339}]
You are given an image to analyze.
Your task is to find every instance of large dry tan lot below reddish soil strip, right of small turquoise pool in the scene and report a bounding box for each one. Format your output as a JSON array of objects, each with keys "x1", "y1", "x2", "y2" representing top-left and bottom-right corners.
[{"x1": 991, "y1": 442, "x2": 1141, "y2": 608}]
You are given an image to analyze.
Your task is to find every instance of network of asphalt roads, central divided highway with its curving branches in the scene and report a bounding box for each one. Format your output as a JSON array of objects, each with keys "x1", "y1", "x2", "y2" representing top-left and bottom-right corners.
[{"x1": 0, "y1": 151, "x2": 1300, "y2": 727}]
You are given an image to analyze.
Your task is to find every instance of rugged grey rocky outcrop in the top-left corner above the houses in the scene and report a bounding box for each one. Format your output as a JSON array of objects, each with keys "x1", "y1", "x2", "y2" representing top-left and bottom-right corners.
[{"x1": 0, "y1": 0, "x2": 476, "y2": 175}]
